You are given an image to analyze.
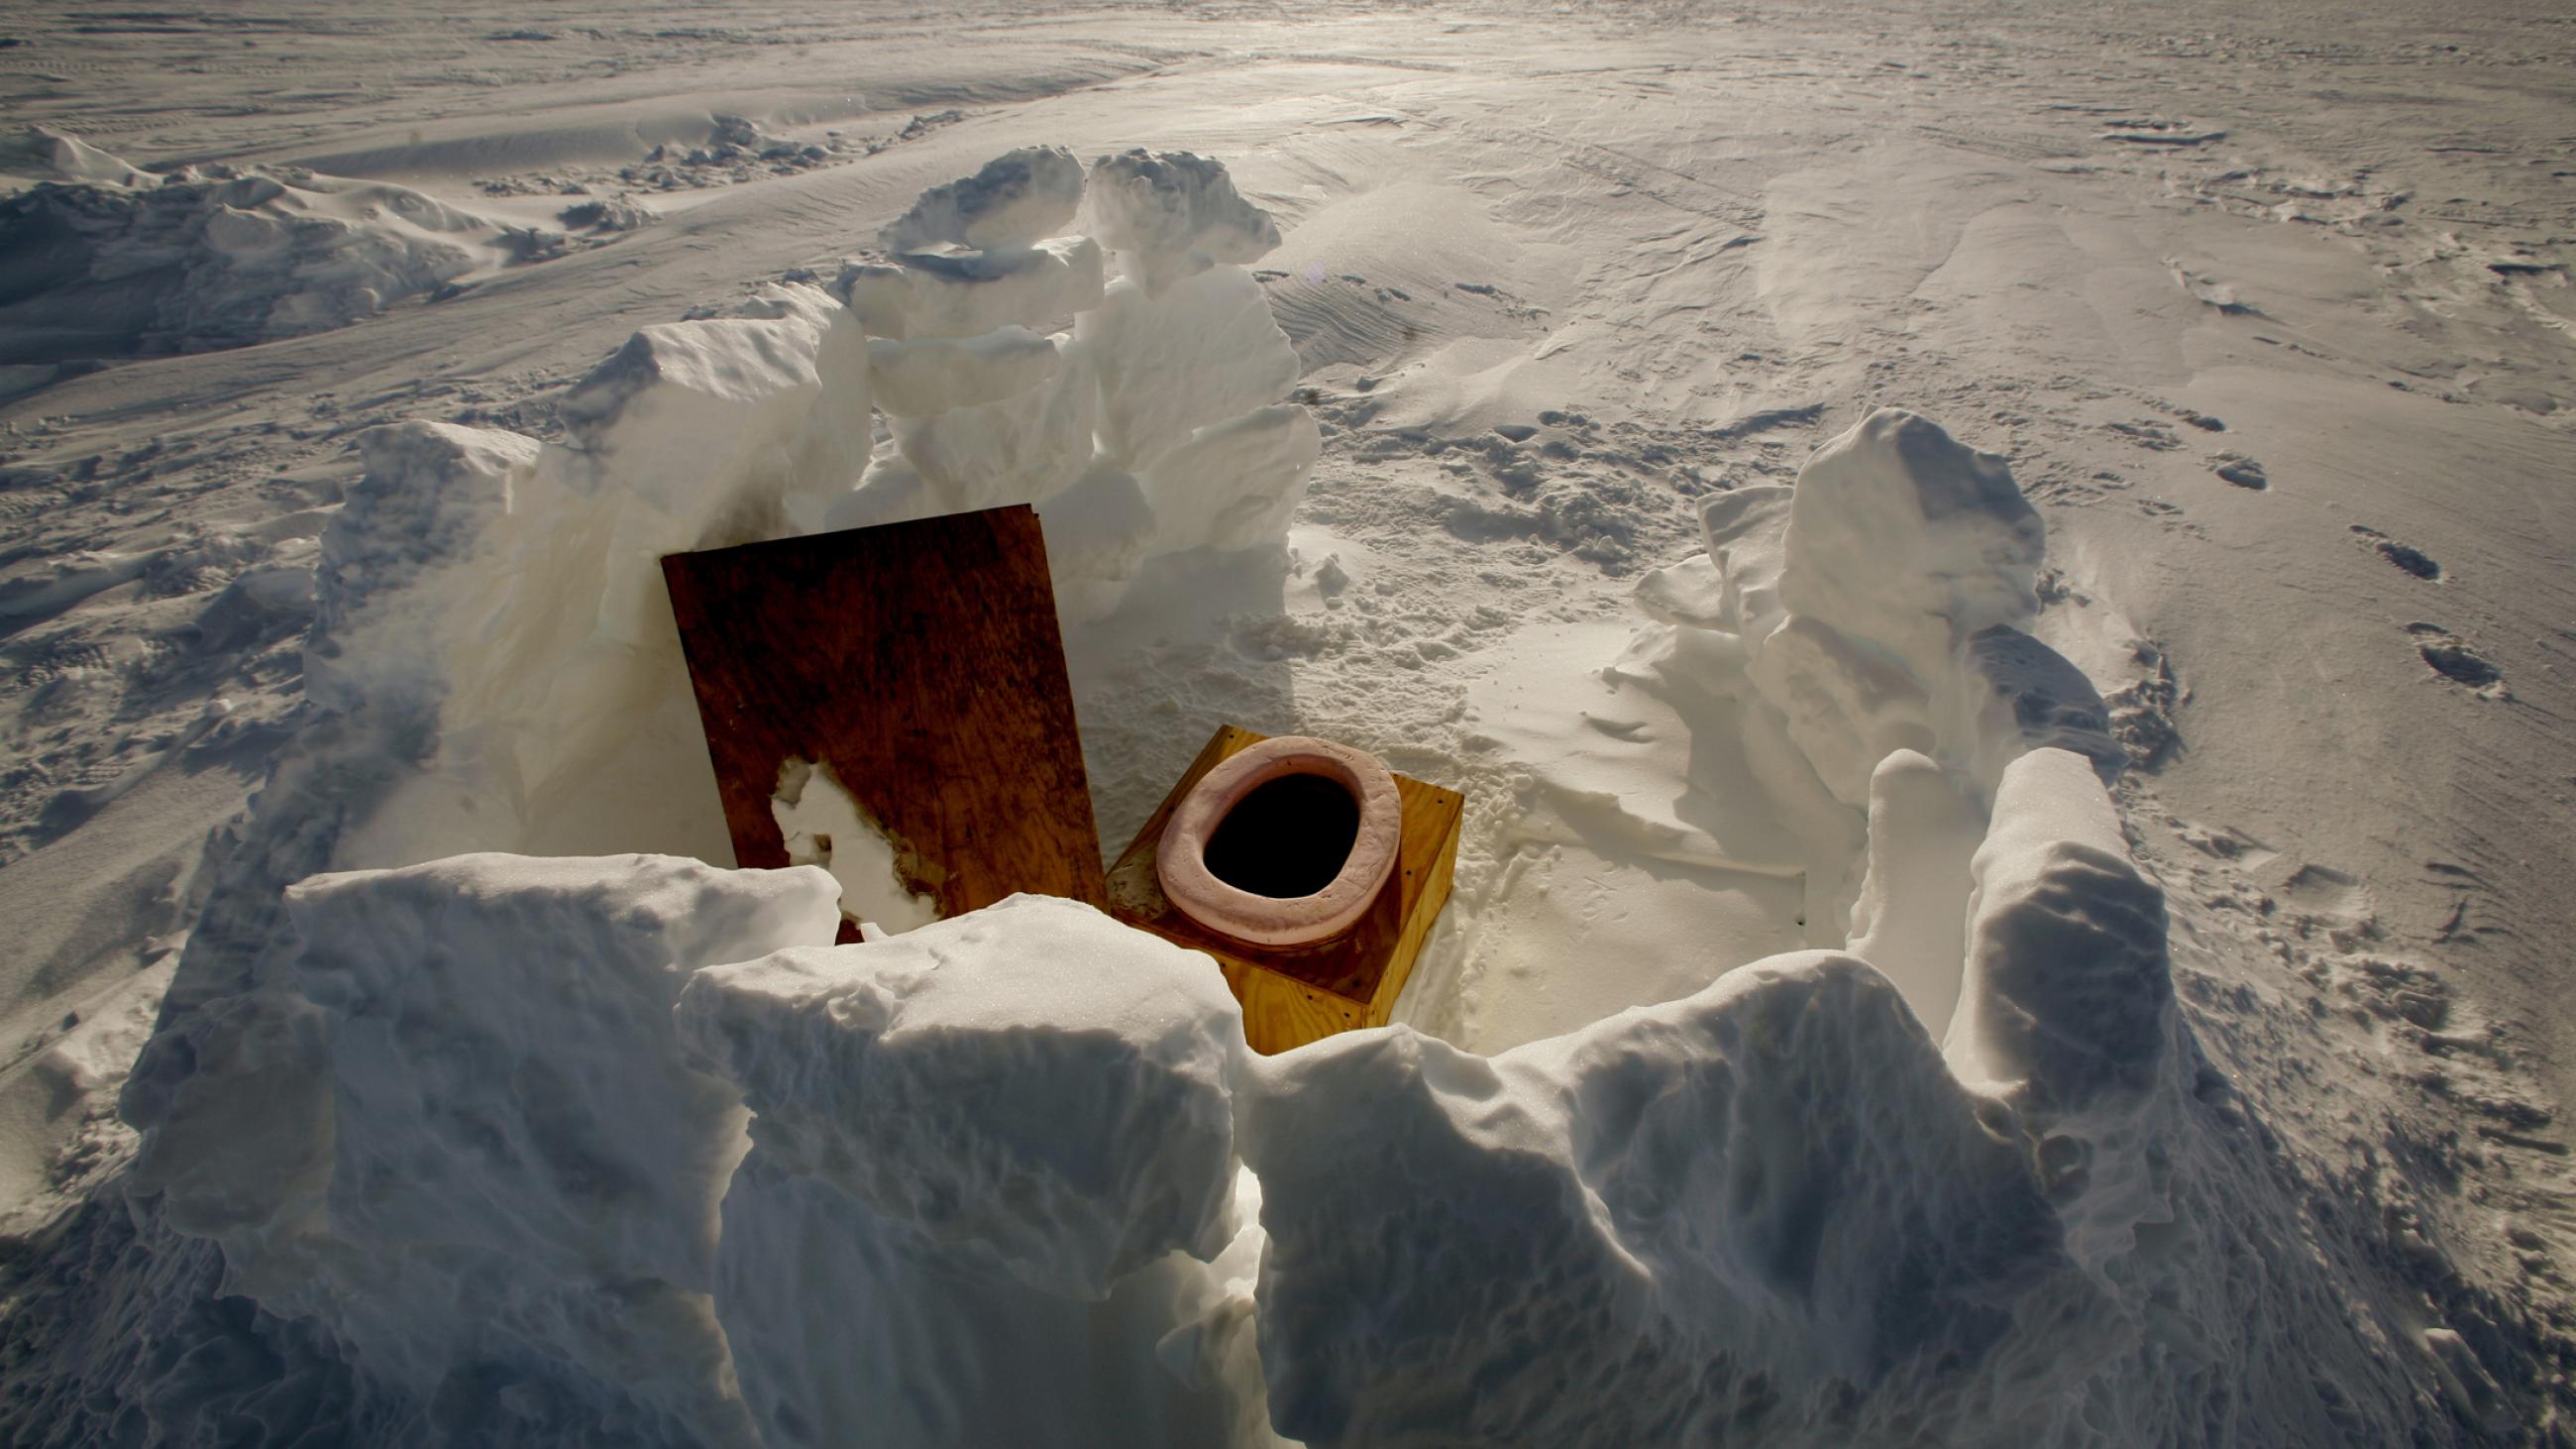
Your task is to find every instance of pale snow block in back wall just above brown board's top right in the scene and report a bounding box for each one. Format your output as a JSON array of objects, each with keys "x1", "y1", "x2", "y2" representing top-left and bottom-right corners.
[{"x1": 892, "y1": 335, "x2": 1100, "y2": 513}]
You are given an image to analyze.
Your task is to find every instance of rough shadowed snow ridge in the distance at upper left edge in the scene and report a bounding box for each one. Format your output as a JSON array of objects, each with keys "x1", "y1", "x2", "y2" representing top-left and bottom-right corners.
[{"x1": 0, "y1": 134, "x2": 564, "y2": 364}]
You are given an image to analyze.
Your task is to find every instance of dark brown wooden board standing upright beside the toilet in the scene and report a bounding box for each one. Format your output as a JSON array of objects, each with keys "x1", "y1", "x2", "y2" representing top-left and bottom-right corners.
[{"x1": 662, "y1": 505, "x2": 1105, "y2": 939}]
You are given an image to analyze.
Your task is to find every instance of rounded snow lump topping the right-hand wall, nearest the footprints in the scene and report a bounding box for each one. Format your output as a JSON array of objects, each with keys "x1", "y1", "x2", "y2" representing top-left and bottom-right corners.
[{"x1": 1780, "y1": 407, "x2": 2048, "y2": 681}]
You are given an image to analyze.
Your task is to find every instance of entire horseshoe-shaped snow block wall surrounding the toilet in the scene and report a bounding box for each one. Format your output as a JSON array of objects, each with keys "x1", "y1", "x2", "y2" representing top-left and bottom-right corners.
[{"x1": 80, "y1": 150, "x2": 2452, "y2": 1449}]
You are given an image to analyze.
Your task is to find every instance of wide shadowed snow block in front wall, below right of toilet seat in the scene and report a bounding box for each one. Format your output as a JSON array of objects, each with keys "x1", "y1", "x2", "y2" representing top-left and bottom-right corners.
[{"x1": 1244, "y1": 951, "x2": 2084, "y2": 1446}]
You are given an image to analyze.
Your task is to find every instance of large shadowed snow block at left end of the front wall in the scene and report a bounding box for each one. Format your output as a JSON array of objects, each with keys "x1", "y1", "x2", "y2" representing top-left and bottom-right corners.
[{"x1": 126, "y1": 856, "x2": 840, "y2": 1444}]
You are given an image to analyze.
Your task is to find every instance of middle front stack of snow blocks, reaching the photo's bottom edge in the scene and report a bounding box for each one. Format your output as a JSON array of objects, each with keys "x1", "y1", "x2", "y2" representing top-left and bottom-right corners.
[{"x1": 678, "y1": 895, "x2": 1257, "y2": 1449}]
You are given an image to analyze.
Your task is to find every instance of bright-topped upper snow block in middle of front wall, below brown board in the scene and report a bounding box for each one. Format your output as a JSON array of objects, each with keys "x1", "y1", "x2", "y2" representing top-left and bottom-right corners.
[{"x1": 680, "y1": 895, "x2": 1246, "y2": 1299}]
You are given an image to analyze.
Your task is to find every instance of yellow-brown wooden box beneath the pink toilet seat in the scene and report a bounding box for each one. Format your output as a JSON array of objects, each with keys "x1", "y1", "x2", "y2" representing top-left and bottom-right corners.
[{"x1": 1108, "y1": 724, "x2": 1465, "y2": 1055}]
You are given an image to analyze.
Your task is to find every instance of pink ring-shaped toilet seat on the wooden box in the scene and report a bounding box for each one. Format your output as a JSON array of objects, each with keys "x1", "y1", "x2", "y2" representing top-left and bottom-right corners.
[{"x1": 1154, "y1": 734, "x2": 1404, "y2": 947}]
